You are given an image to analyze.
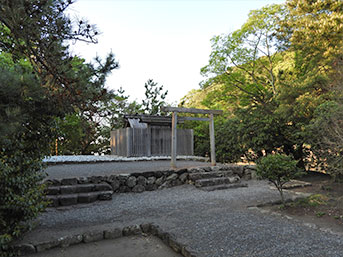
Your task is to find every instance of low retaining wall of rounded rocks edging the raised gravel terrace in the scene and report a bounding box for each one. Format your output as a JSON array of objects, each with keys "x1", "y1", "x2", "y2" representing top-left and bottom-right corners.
[{"x1": 45, "y1": 165, "x2": 255, "y2": 193}]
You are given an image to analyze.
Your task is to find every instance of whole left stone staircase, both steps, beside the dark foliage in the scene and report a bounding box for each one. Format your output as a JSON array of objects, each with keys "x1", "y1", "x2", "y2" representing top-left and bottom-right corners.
[{"x1": 46, "y1": 179, "x2": 113, "y2": 207}]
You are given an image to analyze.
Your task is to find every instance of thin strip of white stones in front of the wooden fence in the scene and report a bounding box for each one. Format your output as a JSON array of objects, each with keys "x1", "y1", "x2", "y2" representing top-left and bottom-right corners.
[{"x1": 43, "y1": 155, "x2": 208, "y2": 164}]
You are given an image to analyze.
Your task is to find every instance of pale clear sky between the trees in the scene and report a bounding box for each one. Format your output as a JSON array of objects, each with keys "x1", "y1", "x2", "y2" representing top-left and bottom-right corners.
[{"x1": 69, "y1": 0, "x2": 285, "y2": 105}]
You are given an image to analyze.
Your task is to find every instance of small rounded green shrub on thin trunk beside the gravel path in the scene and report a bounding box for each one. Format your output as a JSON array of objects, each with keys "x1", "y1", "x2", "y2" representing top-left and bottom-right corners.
[{"x1": 256, "y1": 154, "x2": 302, "y2": 204}]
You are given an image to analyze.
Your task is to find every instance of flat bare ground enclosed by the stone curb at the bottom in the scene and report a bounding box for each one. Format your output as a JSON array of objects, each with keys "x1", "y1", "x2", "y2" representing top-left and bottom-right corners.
[{"x1": 25, "y1": 236, "x2": 181, "y2": 257}]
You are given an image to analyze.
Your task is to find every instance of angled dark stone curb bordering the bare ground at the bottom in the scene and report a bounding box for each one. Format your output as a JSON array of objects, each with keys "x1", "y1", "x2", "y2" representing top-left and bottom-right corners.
[{"x1": 13, "y1": 223, "x2": 198, "y2": 257}]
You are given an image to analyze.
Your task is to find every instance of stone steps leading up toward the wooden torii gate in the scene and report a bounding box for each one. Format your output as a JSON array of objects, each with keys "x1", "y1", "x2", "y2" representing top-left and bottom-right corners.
[{"x1": 188, "y1": 167, "x2": 248, "y2": 191}]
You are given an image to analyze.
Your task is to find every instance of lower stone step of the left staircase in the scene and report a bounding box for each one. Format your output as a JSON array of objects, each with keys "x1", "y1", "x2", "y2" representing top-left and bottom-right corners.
[{"x1": 46, "y1": 190, "x2": 113, "y2": 207}]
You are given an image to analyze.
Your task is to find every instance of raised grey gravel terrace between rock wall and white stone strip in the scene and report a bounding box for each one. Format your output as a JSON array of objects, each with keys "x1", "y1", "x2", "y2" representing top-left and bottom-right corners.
[{"x1": 45, "y1": 160, "x2": 210, "y2": 179}]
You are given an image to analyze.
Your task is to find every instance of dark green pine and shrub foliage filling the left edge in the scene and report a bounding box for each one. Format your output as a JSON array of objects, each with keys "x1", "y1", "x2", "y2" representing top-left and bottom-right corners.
[{"x1": 0, "y1": 0, "x2": 118, "y2": 252}]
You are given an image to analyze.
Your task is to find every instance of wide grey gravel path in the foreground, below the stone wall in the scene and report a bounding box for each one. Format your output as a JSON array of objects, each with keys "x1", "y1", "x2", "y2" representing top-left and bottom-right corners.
[{"x1": 24, "y1": 181, "x2": 343, "y2": 257}]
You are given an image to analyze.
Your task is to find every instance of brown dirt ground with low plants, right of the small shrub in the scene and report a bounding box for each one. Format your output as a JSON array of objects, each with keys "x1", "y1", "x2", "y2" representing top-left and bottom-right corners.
[{"x1": 264, "y1": 172, "x2": 343, "y2": 233}]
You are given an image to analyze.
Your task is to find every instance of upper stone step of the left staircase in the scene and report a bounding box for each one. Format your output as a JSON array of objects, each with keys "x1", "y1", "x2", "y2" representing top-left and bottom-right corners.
[{"x1": 47, "y1": 183, "x2": 112, "y2": 195}]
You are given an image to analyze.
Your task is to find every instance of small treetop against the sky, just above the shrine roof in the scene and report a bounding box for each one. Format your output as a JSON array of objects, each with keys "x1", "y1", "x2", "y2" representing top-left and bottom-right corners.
[{"x1": 142, "y1": 79, "x2": 168, "y2": 115}]
